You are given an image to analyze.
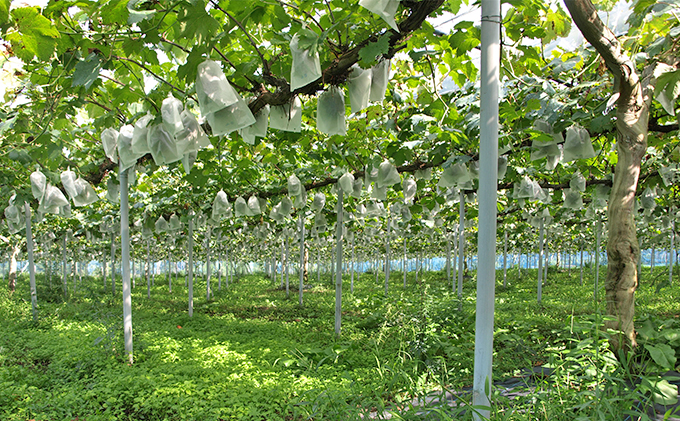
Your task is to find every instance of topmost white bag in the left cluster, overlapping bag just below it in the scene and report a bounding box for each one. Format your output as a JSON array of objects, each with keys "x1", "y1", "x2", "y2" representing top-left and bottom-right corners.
[{"x1": 196, "y1": 60, "x2": 240, "y2": 116}]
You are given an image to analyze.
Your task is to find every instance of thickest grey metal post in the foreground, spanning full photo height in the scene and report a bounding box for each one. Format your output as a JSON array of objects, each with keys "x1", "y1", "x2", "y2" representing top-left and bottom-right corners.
[{"x1": 472, "y1": 0, "x2": 501, "y2": 419}]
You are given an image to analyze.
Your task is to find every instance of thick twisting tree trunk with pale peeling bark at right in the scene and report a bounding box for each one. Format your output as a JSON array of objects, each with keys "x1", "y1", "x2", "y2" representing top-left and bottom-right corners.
[{"x1": 565, "y1": 0, "x2": 650, "y2": 354}]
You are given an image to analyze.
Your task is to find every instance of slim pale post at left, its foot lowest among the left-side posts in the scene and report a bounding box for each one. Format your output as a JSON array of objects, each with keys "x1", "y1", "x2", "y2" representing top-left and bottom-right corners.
[{"x1": 118, "y1": 162, "x2": 134, "y2": 364}]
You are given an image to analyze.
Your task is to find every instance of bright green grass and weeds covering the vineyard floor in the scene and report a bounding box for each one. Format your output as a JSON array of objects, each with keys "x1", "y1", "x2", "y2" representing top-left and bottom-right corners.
[{"x1": 0, "y1": 268, "x2": 680, "y2": 420}]
